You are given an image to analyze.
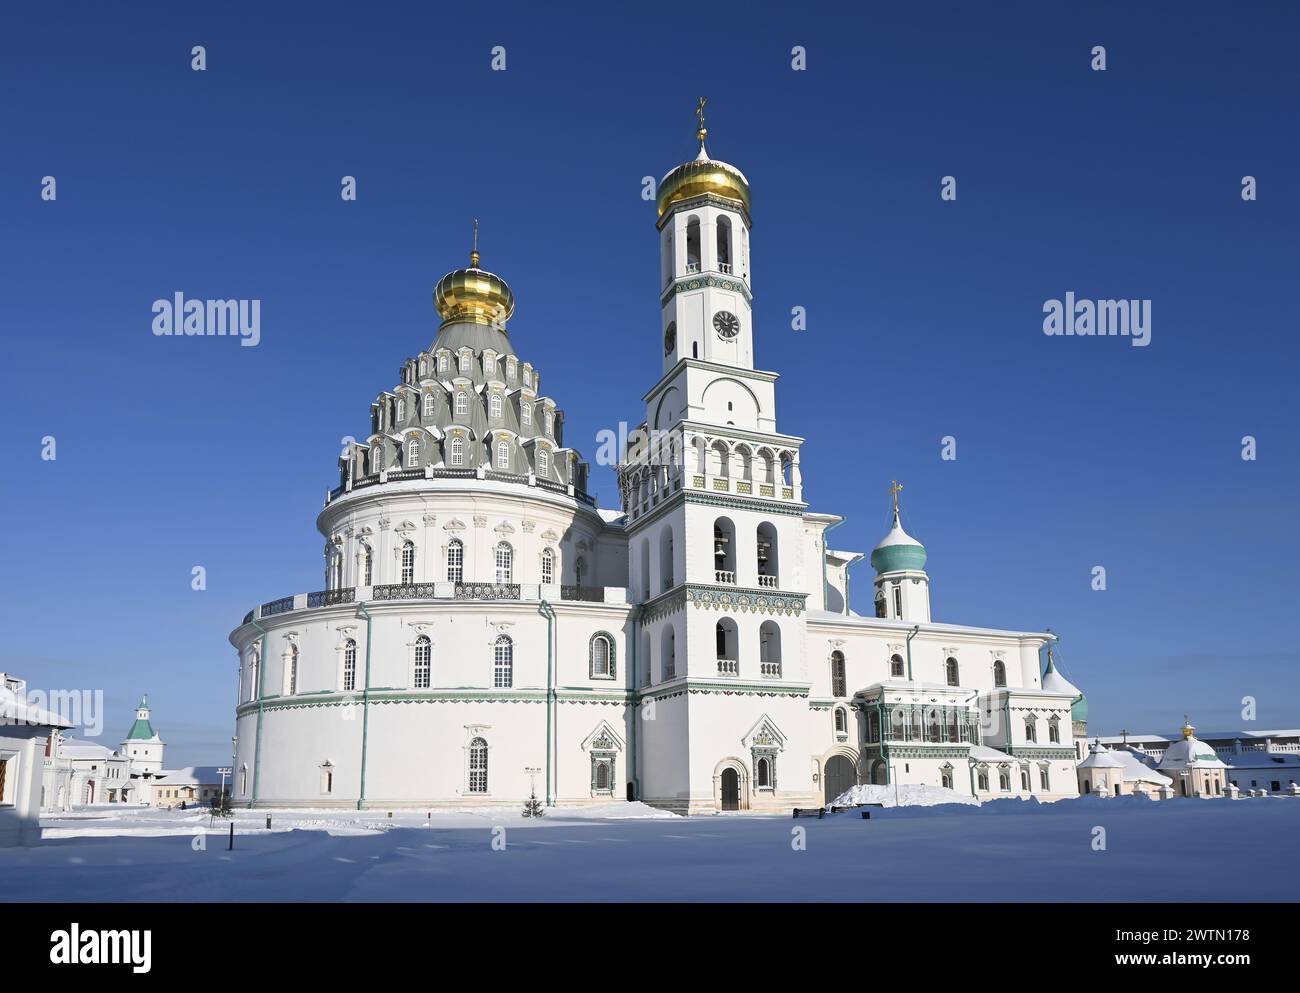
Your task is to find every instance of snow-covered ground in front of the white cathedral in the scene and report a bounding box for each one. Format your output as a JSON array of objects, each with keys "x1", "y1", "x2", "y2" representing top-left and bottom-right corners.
[{"x1": 0, "y1": 790, "x2": 1300, "y2": 902}]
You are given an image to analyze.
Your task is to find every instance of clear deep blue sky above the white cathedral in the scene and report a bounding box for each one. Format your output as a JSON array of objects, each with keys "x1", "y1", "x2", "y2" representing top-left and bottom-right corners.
[{"x1": 0, "y1": 3, "x2": 1300, "y2": 764}]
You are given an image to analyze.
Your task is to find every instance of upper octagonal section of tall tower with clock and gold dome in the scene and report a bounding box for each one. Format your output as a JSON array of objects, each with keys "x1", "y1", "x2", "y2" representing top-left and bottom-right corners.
[{"x1": 658, "y1": 97, "x2": 754, "y2": 373}]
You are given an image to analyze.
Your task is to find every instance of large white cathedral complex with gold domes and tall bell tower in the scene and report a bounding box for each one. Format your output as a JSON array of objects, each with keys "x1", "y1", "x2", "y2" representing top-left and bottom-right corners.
[{"x1": 230, "y1": 106, "x2": 1087, "y2": 814}]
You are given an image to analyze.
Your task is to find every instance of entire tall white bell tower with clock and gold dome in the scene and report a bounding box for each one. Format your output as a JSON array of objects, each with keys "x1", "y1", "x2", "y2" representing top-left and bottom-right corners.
[{"x1": 619, "y1": 99, "x2": 823, "y2": 812}]
